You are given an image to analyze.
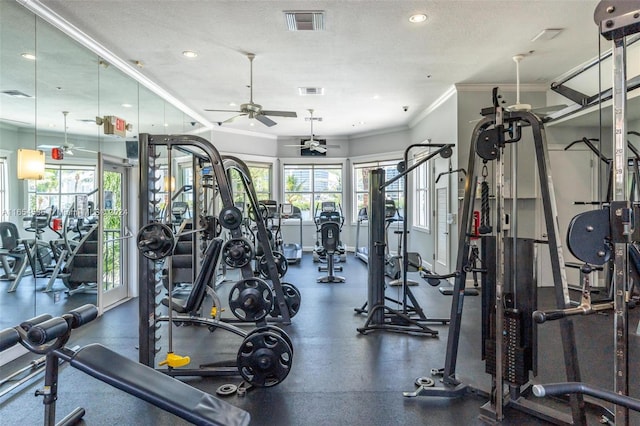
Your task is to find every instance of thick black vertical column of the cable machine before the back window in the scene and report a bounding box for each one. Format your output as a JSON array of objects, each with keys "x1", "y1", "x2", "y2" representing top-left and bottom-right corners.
[{"x1": 368, "y1": 169, "x2": 385, "y2": 325}]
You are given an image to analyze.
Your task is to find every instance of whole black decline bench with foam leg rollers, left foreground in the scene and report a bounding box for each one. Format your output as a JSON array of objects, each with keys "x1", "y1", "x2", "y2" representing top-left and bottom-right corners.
[{"x1": 0, "y1": 305, "x2": 250, "y2": 426}]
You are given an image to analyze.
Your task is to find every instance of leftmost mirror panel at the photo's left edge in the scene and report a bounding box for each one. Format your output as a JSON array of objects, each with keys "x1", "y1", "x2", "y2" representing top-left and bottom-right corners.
[{"x1": 0, "y1": 2, "x2": 36, "y2": 328}]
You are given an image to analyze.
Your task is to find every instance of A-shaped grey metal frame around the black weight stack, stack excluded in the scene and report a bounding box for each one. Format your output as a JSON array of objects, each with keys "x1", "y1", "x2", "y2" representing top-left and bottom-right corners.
[{"x1": 403, "y1": 88, "x2": 586, "y2": 425}]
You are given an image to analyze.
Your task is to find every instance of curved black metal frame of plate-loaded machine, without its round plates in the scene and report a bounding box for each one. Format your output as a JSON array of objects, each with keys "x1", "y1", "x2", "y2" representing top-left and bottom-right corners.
[{"x1": 138, "y1": 133, "x2": 291, "y2": 367}]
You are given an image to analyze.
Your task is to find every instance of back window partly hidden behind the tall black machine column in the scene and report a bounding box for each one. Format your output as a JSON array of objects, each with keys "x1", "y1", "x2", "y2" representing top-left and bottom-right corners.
[{"x1": 351, "y1": 160, "x2": 404, "y2": 222}]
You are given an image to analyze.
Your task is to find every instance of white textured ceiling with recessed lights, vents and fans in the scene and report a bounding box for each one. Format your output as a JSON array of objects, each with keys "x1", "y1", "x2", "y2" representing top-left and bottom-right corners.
[{"x1": 7, "y1": 0, "x2": 608, "y2": 136}]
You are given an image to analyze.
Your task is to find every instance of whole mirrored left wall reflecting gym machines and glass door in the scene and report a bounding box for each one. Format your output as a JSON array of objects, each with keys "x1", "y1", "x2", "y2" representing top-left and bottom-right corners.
[{"x1": 0, "y1": 2, "x2": 202, "y2": 328}]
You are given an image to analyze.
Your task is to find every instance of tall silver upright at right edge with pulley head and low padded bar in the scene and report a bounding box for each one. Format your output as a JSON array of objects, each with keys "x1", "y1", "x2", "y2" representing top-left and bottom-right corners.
[{"x1": 534, "y1": 4, "x2": 640, "y2": 426}]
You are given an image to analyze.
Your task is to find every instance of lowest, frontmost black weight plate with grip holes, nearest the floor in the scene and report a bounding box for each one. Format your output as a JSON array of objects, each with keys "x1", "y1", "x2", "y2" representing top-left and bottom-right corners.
[{"x1": 237, "y1": 331, "x2": 293, "y2": 387}]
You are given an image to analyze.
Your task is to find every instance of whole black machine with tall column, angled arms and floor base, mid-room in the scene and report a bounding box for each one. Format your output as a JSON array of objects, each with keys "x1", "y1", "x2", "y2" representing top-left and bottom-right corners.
[{"x1": 356, "y1": 143, "x2": 454, "y2": 337}]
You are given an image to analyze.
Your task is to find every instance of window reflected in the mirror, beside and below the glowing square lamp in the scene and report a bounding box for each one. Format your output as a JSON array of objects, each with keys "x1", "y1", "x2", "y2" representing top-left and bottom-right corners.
[{"x1": 28, "y1": 165, "x2": 97, "y2": 215}]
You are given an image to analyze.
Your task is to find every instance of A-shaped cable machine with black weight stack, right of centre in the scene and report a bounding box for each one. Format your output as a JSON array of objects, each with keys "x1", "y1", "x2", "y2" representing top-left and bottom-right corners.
[{"x1": 404, "y1": 88, "x2": 586, "y2": 425}]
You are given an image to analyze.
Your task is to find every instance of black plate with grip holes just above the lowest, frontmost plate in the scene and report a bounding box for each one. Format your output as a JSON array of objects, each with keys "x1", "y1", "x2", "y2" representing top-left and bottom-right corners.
[{"x1": 229, "y1": 277, "x2": 273, "y2": 322}]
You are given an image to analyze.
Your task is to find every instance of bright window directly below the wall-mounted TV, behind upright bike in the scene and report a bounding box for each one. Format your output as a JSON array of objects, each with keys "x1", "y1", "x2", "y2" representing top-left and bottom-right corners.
[{"x1": 283, "y1": 164, "x2": 342, "y2": 220}]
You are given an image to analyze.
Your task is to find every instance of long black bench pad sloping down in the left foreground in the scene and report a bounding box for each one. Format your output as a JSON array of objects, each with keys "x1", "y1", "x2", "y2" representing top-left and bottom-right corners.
[{"x1": 70, "y1": 343, "x2": 250, "y2": 426}]
